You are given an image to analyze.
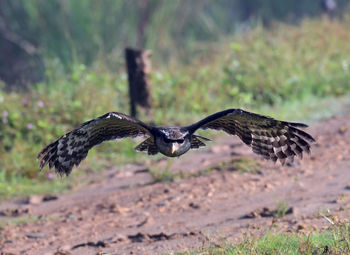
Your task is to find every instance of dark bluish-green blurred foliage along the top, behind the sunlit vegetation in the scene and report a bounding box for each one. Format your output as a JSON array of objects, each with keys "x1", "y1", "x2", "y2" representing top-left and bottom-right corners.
[{"x1": 0, "y1": 0, "x2": 348, "y2": 70}]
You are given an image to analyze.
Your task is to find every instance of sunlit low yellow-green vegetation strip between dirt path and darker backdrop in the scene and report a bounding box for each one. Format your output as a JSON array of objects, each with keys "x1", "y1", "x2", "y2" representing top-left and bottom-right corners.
[{"x1": 0, "y1": 17, "x2": 350, "y2": 199}]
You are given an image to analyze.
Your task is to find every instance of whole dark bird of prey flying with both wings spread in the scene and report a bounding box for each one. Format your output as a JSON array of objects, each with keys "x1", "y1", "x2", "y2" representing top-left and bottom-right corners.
[{"x1": 38, "y1": 109, "x2": 315, "y2": 175}]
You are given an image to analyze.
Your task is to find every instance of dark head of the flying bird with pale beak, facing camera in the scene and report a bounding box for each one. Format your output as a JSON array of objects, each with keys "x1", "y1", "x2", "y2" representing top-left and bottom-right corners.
[{"x1": 156, "y1": 127, "x2": 191, "y2": 157}]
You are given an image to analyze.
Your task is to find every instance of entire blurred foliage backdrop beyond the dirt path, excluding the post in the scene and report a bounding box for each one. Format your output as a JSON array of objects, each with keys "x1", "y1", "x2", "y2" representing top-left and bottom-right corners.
[{"x1": 0, "y1": 0, "x2": 350, "y2": 197}]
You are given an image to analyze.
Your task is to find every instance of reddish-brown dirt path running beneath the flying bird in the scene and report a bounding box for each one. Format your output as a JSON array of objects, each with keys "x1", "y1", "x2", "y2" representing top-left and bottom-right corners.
[{"x1": 0, "y1": 110, "x2": 350, "y2": 254}]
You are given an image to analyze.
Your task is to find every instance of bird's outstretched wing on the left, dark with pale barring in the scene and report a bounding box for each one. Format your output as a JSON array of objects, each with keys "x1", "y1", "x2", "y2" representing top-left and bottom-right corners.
[{"x1": 37, "y1": 112, "x2": 152, "y2": 175}]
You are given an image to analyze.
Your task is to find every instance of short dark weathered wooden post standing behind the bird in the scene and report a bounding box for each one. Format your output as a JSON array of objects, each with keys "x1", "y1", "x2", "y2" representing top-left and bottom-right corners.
[{"x1": 125, "y1": 48, "x2": 152, "y2": 117}]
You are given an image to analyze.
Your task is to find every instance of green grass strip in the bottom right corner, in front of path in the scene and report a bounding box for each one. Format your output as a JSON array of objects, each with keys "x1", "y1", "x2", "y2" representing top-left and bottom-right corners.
[{"x1": 178, "y1": 223, "x2": 350, "y2": 255}]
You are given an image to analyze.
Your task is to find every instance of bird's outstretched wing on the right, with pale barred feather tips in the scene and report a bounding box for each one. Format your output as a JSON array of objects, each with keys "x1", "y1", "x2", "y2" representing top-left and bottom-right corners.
[{"x1": 188, "y1": 109, "x2": 315, "y2": 164}]
